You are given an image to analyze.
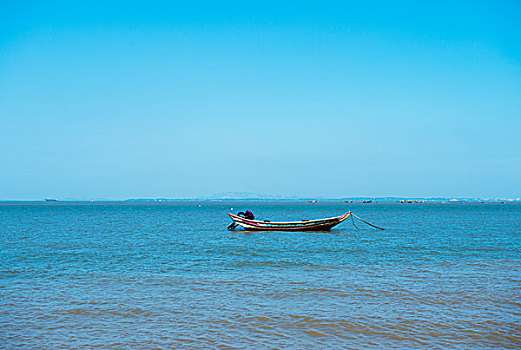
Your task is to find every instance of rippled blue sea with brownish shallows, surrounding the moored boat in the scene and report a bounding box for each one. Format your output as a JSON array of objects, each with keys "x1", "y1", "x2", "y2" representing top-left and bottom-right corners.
[{"x1": 0, "y1": 202, "x2": 521, "y2": 349}]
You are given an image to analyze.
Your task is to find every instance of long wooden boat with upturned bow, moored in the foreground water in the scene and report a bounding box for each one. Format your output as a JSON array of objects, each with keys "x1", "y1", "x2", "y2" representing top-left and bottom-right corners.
[{"x1": 228, "y1": 211, "x2": 351, "y2": 231}]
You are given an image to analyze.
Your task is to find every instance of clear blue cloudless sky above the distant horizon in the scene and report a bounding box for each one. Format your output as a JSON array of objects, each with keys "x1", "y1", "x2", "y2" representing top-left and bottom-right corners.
[{"x1": 0, "y1": 0, "x2": 521, "y2": 199}]
